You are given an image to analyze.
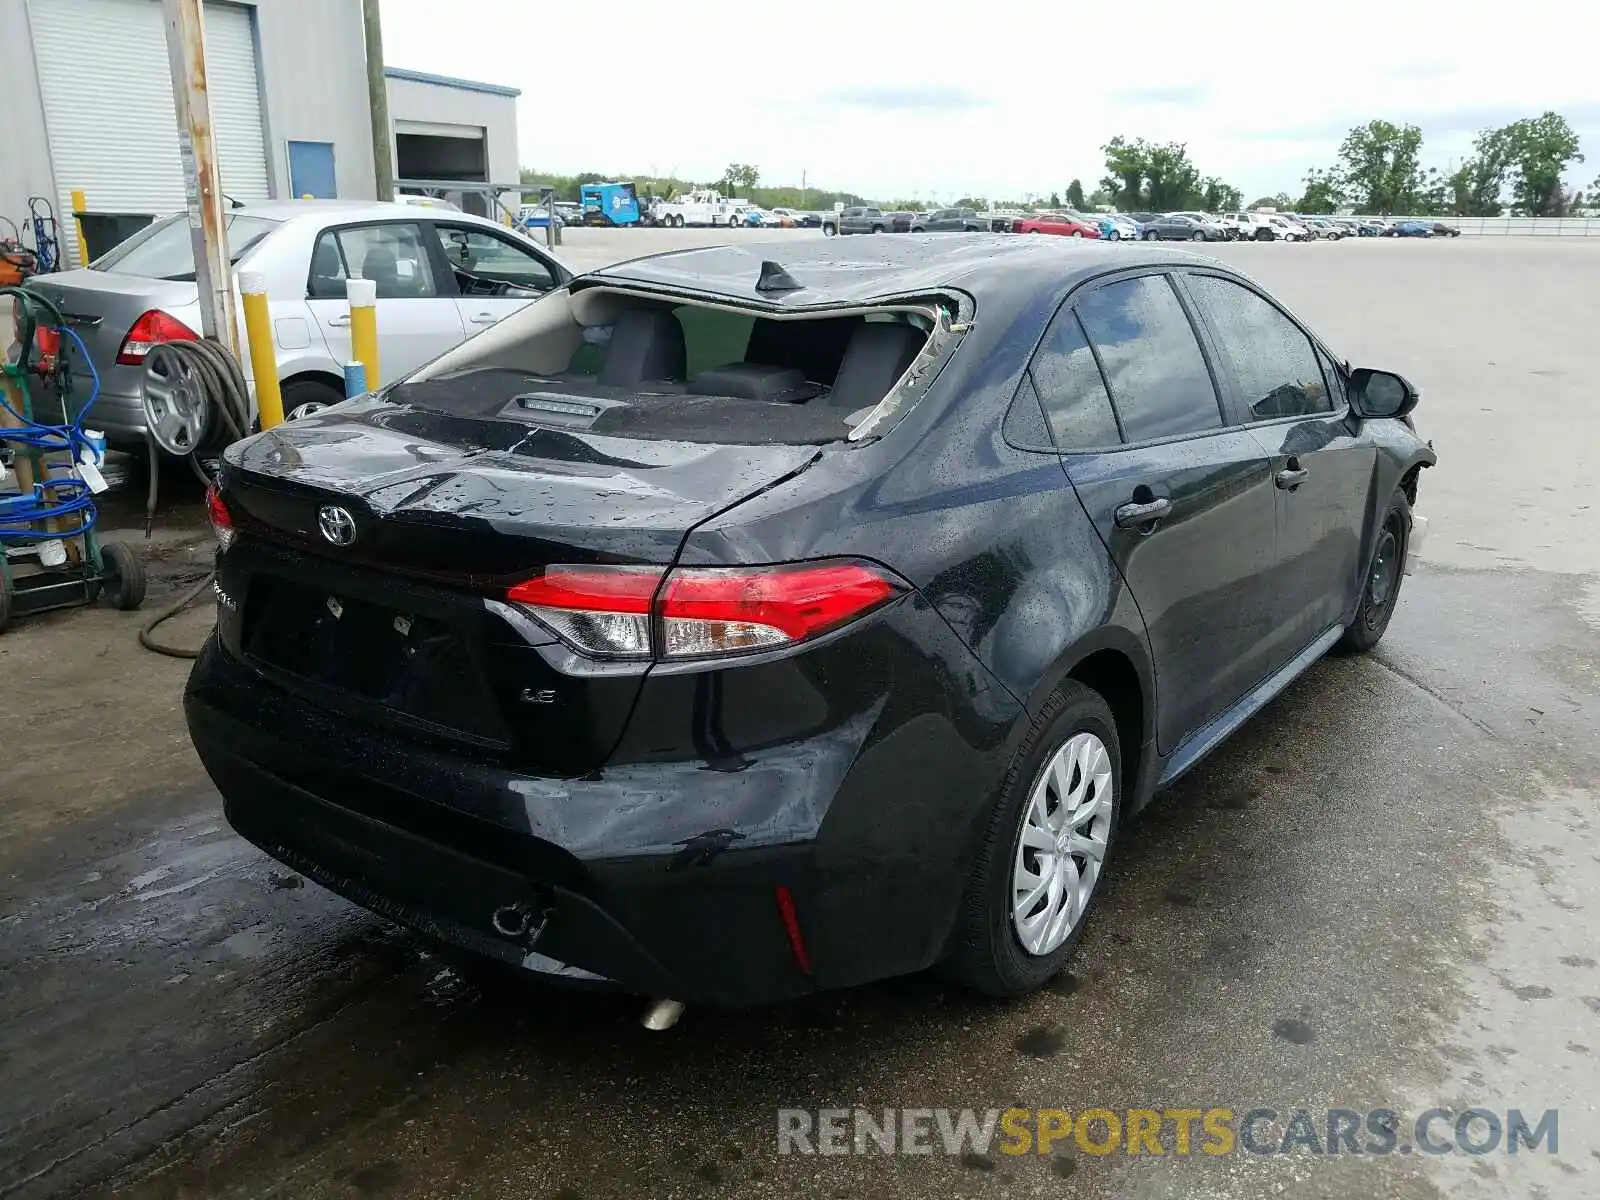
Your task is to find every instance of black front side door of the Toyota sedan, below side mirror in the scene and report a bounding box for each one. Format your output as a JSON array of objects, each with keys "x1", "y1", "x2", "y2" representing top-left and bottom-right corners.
[{"x1": 1182, "y1": 270, "x2": 1378, "y2": 661}]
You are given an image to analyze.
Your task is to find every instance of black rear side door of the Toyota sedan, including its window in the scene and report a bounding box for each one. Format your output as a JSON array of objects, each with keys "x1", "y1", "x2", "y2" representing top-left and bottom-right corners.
[{"x1": 1056, "y1": 272, "x2": 1277, "y2": 754}]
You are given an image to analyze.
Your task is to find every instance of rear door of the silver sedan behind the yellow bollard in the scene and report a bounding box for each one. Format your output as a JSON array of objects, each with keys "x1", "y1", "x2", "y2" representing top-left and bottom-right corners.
[{"x1": 306, "y1": 221, "x2": 466, "y2": 382}]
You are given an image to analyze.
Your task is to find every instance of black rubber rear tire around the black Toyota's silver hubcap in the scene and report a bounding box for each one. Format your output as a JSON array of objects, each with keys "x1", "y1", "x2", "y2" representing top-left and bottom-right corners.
[{"x1": 944, "y1": 680, "x2": 1122, "y2": 997}]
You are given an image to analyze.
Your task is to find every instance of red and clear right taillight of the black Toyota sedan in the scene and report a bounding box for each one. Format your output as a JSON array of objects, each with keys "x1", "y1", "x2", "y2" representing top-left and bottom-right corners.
[{"x1": 506, "y1": 562, "x2": 902, "y2": 659}]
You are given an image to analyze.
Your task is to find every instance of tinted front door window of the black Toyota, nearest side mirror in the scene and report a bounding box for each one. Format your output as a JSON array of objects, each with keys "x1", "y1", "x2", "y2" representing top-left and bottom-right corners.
[{"x1": 1186, "y1": 275, "x2": 1333, "y2": 421}]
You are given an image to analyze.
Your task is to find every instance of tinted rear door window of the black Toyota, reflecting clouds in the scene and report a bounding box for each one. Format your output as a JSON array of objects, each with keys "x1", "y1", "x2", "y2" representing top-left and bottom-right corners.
[{"x1": 1077, "y1": 275, "x2": 1222, "y2": 442}]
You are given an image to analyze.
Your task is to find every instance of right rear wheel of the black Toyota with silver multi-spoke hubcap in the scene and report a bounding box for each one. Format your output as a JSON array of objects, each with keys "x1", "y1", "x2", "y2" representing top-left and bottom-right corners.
[{"x1": 947, "y1": 680, "x2": 1122, "y2": 997}]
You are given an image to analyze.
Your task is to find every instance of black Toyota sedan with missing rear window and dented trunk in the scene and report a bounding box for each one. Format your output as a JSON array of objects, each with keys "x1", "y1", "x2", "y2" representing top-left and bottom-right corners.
[{"x1": 186, "y1": 235, "x2": 1435, "y2": 1005}]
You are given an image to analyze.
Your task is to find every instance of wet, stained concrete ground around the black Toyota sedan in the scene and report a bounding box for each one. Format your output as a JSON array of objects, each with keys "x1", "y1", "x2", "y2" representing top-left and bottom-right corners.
[{"x1": 0, "y1": 230, "x2": 1600, "y2": 1200}]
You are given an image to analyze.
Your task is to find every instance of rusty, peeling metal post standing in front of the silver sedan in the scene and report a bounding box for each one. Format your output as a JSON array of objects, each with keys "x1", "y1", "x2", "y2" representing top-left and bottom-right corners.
[{"x1": 162, "y1": 0, "x2": 238, "y2": 355}]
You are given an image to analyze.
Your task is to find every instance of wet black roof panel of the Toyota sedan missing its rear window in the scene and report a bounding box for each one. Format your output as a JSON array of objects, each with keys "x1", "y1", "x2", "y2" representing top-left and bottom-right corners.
[{"x1": 576, "y1": 234, "x2": 1221, "y2": 309}]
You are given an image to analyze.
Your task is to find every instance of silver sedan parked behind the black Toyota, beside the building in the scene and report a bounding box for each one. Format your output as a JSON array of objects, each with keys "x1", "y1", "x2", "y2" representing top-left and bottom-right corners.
[{"x1": 29, "y1": 200, "x2": 573, "y2": 448}]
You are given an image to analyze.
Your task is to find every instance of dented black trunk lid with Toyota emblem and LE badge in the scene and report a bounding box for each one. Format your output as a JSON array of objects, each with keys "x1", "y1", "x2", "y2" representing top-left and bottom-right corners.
[{"x1": 219, "y1": 402, "x2": 818, "y2": 776}]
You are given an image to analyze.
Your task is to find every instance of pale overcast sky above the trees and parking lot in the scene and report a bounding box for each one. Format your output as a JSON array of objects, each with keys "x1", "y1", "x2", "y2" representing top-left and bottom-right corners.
[{"x1": 382, "y1": 0, "x2": 1600, "y2": 203}]
